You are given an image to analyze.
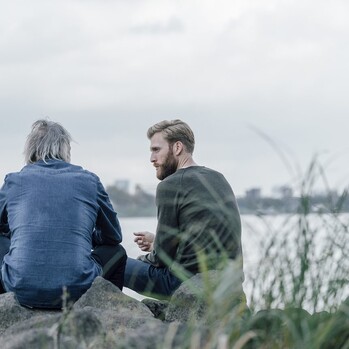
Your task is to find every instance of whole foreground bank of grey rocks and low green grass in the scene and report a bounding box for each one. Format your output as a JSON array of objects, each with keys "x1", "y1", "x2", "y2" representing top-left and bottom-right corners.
[{"x1": 0, "y1": 268, "x2": 349, "y2": 349}]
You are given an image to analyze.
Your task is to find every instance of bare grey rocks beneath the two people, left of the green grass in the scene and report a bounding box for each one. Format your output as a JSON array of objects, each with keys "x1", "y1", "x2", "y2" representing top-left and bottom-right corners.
[{"x1": 0, "y1": 272, "x2": 237, "y2": 349}]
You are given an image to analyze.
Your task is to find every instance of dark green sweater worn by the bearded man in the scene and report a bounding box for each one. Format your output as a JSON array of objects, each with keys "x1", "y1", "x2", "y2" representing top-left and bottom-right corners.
[{"x1": 154, "y1": 166, "x2": 242, "y2": 274}]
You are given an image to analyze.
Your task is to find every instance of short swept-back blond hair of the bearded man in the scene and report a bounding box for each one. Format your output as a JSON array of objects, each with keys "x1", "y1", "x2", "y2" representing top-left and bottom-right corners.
[{"x1": 147, "y1": 119, "x2": 195, "y2": 154}]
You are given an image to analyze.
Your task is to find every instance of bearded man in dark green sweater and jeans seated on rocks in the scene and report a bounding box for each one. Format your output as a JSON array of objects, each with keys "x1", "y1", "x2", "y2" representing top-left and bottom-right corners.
[{"x1": 125, "y1": 120, "x2": 243, "y2": 298}]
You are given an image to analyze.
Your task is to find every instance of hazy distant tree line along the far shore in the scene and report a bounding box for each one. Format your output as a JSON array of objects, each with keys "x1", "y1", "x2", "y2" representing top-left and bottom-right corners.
[{"x1": 106, "y1": 185, "x2": 349, "y2": 217}]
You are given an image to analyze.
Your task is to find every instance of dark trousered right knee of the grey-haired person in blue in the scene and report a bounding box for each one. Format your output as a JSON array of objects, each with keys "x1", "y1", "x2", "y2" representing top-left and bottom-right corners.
[{"x1": 92, "y1": 245, "x2": 127, "y2": 291}]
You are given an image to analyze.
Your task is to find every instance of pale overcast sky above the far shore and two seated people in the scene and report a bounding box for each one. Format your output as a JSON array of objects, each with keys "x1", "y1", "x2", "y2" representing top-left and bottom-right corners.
[{"x1": 0, "y1": 0, "x2": 349, "y2": 195}]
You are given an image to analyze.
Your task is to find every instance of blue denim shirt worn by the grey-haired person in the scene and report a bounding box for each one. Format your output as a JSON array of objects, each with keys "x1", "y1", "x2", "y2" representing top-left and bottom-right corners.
[{"x1": 0, "y1": 160, "x2": 122, "y2": 308}]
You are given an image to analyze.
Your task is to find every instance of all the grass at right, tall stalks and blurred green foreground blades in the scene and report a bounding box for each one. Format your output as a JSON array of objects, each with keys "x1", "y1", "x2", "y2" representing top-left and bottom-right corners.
[{"x1": 171, "y1": 159, "x2": 349, "y2": 349}]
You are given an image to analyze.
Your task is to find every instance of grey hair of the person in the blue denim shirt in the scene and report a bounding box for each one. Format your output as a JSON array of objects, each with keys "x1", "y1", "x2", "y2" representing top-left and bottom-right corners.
[{"x1": 24, "y1": 120, "x2": 72, "y2": 164}]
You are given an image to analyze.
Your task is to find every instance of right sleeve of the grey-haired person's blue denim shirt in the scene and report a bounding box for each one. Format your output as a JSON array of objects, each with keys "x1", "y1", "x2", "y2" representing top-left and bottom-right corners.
[{"x1": 93, "y1": 180, "x2": 122, "y2": 246}]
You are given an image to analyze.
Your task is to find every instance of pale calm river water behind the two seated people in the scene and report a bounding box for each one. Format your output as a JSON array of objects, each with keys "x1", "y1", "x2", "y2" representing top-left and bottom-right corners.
[{"x1": 119, "y1": 214, "x2": 349, "y2": 308}]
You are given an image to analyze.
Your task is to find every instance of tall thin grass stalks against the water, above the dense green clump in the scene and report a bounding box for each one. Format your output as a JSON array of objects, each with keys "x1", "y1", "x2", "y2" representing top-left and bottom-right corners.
[{"x1": 250, "y1": 160, "x2": 349, "y2": 313}]
